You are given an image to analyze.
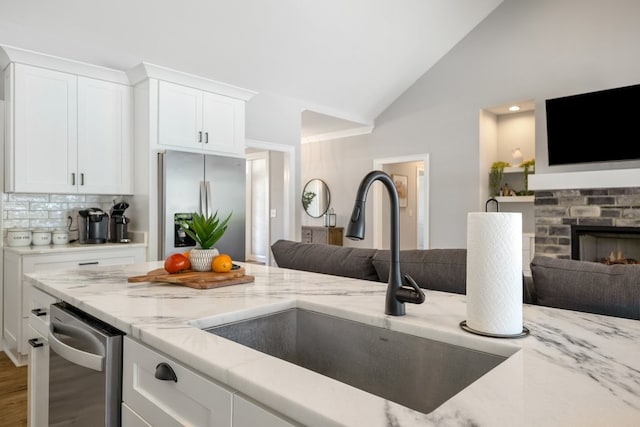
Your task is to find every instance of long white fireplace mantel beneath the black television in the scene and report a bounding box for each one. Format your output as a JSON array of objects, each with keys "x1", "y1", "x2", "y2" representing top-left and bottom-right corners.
[{"x1": 529, "y1": 168, "x2": 640, "y2": 190}]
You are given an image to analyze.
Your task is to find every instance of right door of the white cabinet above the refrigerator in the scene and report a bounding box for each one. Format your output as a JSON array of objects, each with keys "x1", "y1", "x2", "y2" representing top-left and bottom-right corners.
[{"x1": 202, "y1": 92, "x2": 244, "y2": 155}]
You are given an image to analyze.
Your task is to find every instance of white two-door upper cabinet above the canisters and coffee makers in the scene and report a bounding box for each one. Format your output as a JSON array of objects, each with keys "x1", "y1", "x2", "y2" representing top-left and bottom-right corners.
[{"x1": 5, "y1": 63, "x2": 133, "y2": 194}]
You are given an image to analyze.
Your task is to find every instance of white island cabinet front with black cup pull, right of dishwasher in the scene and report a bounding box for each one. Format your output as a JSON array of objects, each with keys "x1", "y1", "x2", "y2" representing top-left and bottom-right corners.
[{"x1": 122, "y1": 337, "x2": 296, "y2": 427}]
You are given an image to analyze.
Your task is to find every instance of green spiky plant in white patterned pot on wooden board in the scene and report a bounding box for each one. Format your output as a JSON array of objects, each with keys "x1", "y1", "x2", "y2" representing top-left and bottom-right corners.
[{"x1": 180, "y1": 211, "x2": 231, "y2": 271}]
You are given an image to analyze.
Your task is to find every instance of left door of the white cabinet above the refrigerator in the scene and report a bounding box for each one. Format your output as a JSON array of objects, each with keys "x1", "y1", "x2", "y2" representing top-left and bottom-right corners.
[{"x1": 158, "y1": 81, "x2": 204, "y2": 151}]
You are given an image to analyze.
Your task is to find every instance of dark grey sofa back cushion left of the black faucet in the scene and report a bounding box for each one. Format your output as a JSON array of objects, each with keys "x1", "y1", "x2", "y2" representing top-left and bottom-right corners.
[{"x1": 271, "y1": 240, "x2": 378, "y2": 281}]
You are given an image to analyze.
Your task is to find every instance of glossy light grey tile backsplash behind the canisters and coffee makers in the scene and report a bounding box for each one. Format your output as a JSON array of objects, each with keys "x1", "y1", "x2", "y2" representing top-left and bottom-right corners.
[{"x1": 2, "y1": 193, "x2": 129, "y2": 239}]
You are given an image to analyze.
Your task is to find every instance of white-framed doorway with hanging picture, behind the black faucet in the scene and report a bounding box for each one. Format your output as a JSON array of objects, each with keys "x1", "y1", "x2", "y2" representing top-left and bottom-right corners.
[{"x1": 372, "y1": 153, "x2": 429, "y2": 249}]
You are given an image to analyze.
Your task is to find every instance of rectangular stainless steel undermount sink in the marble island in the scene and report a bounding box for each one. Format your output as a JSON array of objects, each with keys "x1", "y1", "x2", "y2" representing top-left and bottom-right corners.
[{"x1": 204, "y1": 308, "x2": 507, "y2": 413}]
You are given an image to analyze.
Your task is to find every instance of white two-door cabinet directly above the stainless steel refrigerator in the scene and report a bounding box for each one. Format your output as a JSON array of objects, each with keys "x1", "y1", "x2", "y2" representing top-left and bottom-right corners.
[{"x1": 158, "y1": 81, "x2": 245, "y2": 156}]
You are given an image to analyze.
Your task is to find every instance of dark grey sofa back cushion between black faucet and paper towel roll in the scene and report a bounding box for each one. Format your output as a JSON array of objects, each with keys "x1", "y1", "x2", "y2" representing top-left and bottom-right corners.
[{"x1": 373, "y1": 249, "x2": 467, "y2": 294}]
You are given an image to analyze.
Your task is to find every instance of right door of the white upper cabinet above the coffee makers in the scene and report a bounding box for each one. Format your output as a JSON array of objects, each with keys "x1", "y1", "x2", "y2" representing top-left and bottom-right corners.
[{"x1": 77, "y1": 77, "x2": 133, "y2": 194}]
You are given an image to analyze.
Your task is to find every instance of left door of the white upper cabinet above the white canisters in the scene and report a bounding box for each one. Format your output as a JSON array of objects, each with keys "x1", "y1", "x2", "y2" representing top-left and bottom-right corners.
[{"x1": 7, "y1": 64, "x2": 78, "y2": 193}]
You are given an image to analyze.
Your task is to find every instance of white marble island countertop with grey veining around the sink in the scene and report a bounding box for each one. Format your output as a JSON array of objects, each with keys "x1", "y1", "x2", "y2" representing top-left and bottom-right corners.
[{"x1": 28, "y1": 262, "x2": 640, "y2": 426}]
